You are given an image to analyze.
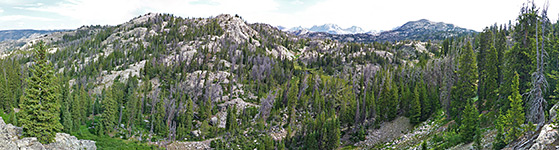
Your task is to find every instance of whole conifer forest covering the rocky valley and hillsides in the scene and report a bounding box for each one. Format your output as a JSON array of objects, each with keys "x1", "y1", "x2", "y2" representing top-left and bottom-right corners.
[{"x1": 0, "y1": 3, "x2": 559, "y2": 150}]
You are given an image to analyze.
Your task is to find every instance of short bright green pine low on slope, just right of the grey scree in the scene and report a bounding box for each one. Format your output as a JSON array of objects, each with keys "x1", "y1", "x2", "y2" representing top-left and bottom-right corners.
[{"x1": 460, "y1": 100, "x2": 479, "y2": 143}]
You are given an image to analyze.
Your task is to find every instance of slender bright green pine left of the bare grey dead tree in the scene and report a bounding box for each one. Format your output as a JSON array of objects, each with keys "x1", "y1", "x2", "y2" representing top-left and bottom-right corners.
[{"x1": 506, "y1": 73, "x2": 524, "y2": 141}]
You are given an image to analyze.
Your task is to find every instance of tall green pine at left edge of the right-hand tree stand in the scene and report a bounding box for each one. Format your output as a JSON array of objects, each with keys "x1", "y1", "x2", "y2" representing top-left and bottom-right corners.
[{"x1": 450, "y1": 41, "x2": 477, "y2": 124}]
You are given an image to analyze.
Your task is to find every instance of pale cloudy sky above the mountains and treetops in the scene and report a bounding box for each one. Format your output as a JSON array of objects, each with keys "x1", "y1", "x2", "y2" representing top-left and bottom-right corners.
[{"x1": 0, "y1": 0, "x2": 559, "y2": 31}]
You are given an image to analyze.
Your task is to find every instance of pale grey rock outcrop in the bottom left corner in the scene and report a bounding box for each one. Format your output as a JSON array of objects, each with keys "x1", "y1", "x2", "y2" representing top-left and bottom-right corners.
[{"x1": 0, "y1": 117, "x2": 97, "y2": 150}]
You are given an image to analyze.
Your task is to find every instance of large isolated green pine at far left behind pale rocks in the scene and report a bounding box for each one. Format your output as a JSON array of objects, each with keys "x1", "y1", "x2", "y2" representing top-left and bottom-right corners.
[{"x1": 19, "y1": 41, "x2": 63, "y2": 144}]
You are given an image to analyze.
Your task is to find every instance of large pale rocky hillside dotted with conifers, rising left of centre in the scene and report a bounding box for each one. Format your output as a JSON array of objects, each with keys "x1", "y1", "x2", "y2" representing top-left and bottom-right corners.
[{"x1": 0, "y1": 13, "x2": 437, "y2": 149}]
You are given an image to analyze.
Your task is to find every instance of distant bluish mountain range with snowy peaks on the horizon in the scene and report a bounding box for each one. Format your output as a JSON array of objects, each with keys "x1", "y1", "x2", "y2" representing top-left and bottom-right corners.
[{"x1": 300, "y1": 19, "x2": 476, "y2": 43}]
